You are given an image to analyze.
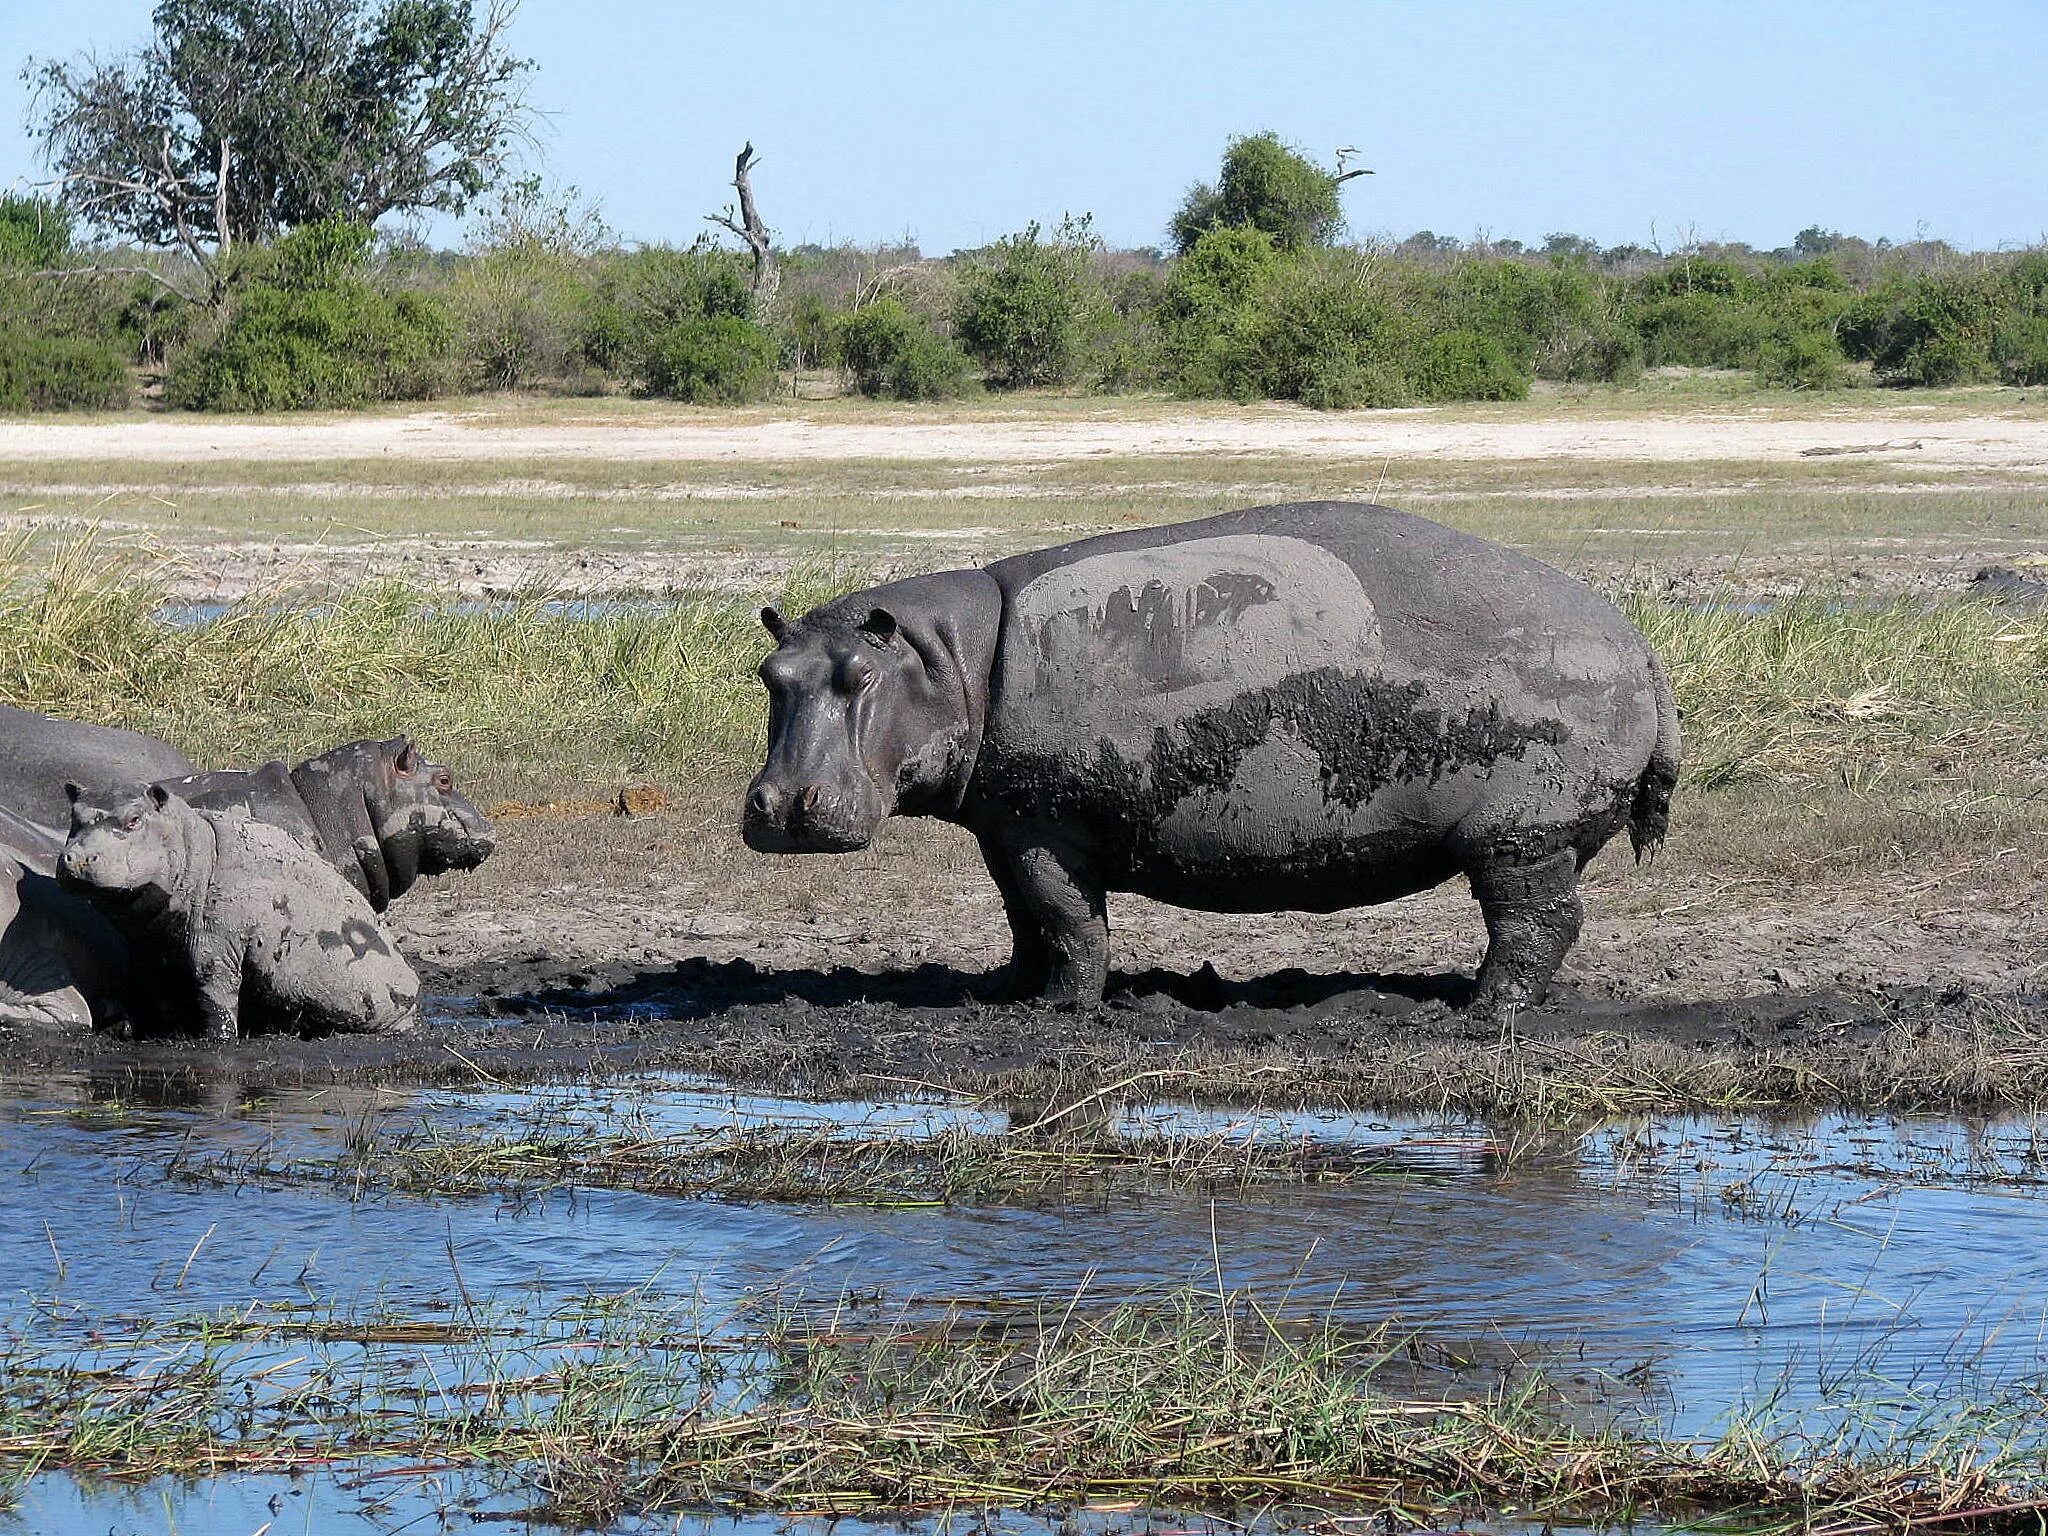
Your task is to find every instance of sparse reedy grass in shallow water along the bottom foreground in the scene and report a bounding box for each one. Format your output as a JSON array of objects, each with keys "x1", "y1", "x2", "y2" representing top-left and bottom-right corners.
[{"x1": 0, "y1": 1290, "x2": 2048, "y2": 1536}]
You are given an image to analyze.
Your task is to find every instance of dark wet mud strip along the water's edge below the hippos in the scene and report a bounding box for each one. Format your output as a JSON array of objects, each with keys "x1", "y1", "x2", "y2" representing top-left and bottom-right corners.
[{"x1": 0, "y1": 958, "x2": 2048, "y2": 1114}]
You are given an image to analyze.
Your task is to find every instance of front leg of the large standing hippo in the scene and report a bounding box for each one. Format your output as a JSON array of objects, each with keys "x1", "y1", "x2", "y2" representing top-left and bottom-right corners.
[{"x1": 981, "y1": 827, "x2": 1110, "y2": 1008}]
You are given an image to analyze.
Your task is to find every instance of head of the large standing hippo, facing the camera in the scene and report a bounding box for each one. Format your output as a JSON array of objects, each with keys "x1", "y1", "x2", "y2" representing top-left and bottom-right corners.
[{"x1": 741, "y1": 578, "x2": 987, "y2": 854}]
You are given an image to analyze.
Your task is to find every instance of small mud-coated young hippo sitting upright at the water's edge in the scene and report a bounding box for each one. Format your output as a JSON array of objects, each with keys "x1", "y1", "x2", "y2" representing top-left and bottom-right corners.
[{"x1": 57, "y1": 784, "x2": 420, "y2": 1040}]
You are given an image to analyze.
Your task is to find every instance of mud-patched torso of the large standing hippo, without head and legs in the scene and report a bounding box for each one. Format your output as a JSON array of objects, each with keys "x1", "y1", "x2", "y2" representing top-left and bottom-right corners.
[{"x1": 977, "y1": 502, "x2": 1657, "y2": 909}]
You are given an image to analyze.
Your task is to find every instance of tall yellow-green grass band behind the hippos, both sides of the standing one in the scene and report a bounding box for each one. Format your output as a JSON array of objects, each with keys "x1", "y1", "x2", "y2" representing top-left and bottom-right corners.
[{"x1": 0, "y1": 537, "x2": 2048, "y2": 823}]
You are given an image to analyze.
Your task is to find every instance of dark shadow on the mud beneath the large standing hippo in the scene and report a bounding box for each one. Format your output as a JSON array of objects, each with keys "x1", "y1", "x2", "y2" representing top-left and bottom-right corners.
[{"x1": 492, "y1": 958, "x2": 1473, "y2": 1020}]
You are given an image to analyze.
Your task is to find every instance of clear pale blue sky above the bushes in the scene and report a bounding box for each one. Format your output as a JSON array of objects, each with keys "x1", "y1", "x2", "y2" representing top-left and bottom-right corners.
[{"x1": 0, "y1": 0, "x2": 2048, "y2": 254}]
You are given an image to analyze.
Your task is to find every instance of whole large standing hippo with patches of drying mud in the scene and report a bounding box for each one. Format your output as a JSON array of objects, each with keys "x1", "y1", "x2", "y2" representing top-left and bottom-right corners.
[{"x1": 743, "y1": 502, "x2": 1679, "y2": 1012}]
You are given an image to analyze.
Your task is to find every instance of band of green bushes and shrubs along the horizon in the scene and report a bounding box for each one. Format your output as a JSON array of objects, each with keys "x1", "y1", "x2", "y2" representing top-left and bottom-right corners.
[{"x1": 0, "y1": 184, "x2": 2048, "y2": 412}]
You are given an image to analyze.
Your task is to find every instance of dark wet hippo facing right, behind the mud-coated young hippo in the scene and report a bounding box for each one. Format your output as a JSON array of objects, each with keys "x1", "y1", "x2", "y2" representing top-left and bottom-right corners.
[{"x1": 160, "y1": 737, "x2": 498, "y2": 911}]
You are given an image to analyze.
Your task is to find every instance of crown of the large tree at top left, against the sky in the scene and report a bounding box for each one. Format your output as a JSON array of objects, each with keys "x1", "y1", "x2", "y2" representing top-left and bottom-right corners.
[{"x1": 25, "y1": 0, "x2": 532, "y2": 297}]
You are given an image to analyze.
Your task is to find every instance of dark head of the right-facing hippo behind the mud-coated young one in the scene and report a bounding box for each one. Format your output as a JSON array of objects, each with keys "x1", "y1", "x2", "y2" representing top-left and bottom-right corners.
[{"x1": 291, "y1": 735, "x2": 498, "y2": 911}]
